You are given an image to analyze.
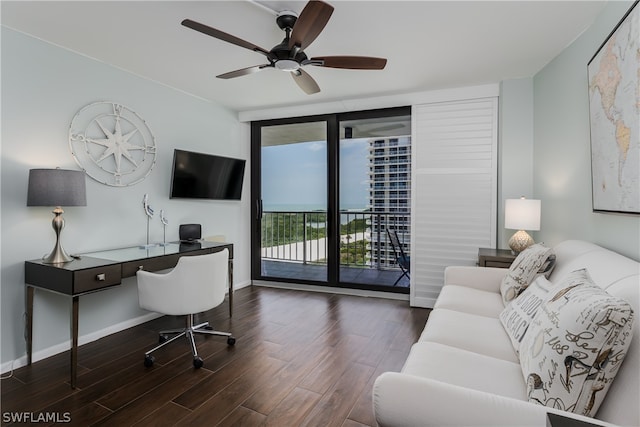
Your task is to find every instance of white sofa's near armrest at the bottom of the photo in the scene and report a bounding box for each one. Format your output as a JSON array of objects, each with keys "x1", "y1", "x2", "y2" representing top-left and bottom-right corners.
[{"x1": 373, "y1": 372, "x2": 611, "y2": 427}]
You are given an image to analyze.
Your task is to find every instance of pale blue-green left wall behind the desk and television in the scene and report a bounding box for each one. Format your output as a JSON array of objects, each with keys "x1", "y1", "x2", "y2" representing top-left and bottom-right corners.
[{"x1": 1, "y1": 27, "x2": 250, "y2": 371}]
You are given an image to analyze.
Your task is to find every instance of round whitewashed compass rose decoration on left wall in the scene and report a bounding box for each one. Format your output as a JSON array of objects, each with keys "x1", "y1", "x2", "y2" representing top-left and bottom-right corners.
[{"x1": 69, "y1": 101, "x2": 156, "y2": 187}]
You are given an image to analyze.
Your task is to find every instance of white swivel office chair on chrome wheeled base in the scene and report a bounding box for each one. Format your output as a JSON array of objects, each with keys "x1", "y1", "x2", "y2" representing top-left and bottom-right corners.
[{"x1": 137, "y1": 249, "x2": 236, "y2": 368}]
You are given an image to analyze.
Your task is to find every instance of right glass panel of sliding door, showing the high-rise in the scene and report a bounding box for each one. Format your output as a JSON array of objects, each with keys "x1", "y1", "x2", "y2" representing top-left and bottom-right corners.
[{"x1": 339, "y1": 110, "x2": 411, "y2": 289}]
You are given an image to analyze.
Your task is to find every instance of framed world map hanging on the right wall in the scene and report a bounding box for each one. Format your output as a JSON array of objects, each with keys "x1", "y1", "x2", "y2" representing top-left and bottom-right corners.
[{"x1": 587, "y1": 1, "x2": 640, "y2": 214}]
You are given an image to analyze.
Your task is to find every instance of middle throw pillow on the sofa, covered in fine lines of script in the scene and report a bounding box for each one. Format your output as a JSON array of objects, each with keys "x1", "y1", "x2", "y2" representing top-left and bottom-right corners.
[{"x1": 500, "y1": 275, "x2": 556, "y2": 353}]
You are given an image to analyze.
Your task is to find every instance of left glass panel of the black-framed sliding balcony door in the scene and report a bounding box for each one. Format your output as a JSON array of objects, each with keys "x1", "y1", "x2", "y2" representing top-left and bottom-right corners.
[{"x1": 252, "y1": 121, "x2": 328, "y2": 282}]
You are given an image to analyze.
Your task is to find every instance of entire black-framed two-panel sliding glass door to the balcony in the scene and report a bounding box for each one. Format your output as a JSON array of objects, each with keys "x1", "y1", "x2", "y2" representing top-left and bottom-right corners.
[{"x1": 251, "y1": 108, "x2": 411, "y2": 293}]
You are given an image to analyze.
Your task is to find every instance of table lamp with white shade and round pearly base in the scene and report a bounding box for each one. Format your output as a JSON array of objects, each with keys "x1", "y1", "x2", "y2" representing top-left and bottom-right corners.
[{"x1": 504, "y1": 197, "x2": 540, "y2": 254}]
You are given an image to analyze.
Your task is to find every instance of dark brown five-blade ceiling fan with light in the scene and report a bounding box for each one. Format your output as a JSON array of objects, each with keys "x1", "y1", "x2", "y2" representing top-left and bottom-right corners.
[{"x1": 182, "y1": 0, "x2": 387, "y2": 95}]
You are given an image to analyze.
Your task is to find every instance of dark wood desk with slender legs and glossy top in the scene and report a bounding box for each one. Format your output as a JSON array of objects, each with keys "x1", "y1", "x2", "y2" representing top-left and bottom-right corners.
[{"x1": 24, "y1": 241, "x2": 233, "y2": 388}]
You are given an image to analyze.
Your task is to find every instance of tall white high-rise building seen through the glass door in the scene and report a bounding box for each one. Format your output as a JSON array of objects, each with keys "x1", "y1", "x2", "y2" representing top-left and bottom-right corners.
[{"x1": 368, "y1": 136, "x2": 411, "y2": 268}]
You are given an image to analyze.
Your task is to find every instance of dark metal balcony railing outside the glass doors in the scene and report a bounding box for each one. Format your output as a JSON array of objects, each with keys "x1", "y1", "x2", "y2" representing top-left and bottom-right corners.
[{"x1": 261, "y1": 210, "x2": 411, "y2": 269}]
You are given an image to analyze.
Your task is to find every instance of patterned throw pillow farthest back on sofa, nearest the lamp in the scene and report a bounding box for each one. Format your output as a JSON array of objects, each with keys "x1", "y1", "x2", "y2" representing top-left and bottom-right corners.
[{"x1": 500, "y1": 243, "x2": 555, "y2": 306}]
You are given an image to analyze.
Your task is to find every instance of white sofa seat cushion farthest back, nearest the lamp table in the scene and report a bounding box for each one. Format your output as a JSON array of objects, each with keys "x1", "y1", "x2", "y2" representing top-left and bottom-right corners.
[{"x1": 433, "y1": 285, "x2": 504, "y2": 319}]
